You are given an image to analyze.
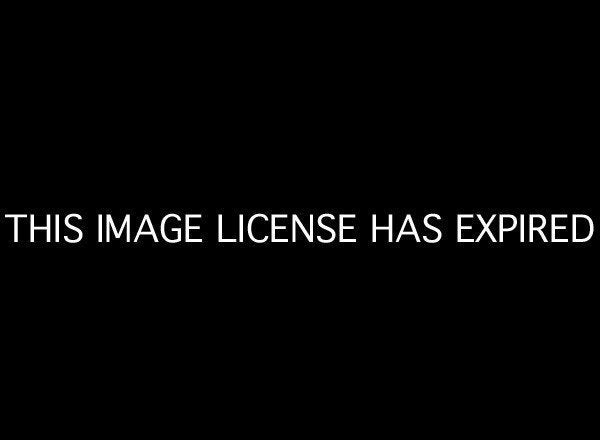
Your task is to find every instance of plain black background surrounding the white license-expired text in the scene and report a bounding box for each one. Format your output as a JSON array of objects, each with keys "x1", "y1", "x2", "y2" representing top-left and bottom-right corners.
[{"x1": 1, "y1": 5, "x2": 598, "y2": 433}]
